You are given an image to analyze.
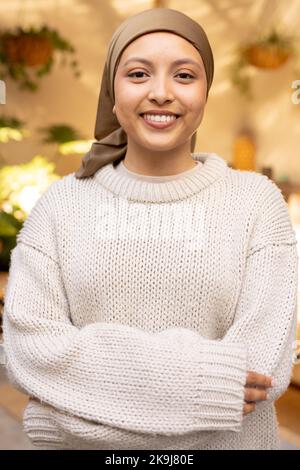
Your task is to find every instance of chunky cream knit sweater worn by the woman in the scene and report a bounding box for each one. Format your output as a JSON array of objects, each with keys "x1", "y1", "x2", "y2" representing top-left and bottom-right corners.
[{"x1": 4, "y1": 153, "x2": 298, "y2": 450}]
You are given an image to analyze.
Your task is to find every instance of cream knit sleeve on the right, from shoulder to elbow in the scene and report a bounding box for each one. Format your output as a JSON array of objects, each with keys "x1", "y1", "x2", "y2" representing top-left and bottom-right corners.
[{"x1": 223, "y1": 176, "x2": 299, "y2": 407}]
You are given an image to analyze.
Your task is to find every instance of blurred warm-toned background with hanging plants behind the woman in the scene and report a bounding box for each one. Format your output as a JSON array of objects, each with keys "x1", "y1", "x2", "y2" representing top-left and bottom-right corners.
[{"x1": 0, "y1": 0, "x2": 300, "y2": 450}]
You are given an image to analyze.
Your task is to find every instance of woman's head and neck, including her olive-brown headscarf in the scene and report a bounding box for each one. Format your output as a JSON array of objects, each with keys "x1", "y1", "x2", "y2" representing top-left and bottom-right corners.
[{"x1": 76, "y1": 8, "x2": 214, "y2": 179}]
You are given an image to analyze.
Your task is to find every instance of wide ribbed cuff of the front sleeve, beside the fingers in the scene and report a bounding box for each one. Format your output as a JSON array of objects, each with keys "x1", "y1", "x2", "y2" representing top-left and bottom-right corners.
[{"x1": 195, "y1": 341, "x2": 247, "y2": 432}]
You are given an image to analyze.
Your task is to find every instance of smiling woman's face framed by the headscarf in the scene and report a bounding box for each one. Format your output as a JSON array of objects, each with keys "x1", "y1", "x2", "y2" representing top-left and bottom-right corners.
[{"x1": 114, "y1": 32, "x2": 207, "y2": 156}]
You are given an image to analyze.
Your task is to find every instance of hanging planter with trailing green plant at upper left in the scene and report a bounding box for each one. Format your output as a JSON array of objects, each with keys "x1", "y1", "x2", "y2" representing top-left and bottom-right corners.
[{"x1": 0, "y1": 25, "x2": 81, "y2": 91}]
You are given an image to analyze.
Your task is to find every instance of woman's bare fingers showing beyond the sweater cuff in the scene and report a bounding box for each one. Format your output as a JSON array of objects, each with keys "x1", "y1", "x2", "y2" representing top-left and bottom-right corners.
[{"x1": 244, "y1": 371, "x2": 273, "y2": 415}]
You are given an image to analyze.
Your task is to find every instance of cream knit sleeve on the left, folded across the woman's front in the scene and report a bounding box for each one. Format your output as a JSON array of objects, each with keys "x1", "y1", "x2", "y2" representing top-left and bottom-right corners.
[{"x1": 3, "y1": 183, "x2": 246, "y2": 435}]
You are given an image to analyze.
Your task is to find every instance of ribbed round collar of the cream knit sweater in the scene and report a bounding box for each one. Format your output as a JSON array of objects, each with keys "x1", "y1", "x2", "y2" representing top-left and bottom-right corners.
[{"x1": 94, "y1": 153, "x2": 228, "y2": 202}]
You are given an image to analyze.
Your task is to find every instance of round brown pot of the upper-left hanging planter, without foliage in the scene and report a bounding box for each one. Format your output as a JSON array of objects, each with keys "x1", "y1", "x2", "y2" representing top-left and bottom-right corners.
[{"x1": 3, "y1": 34, "x2": 53, "y2": 67}]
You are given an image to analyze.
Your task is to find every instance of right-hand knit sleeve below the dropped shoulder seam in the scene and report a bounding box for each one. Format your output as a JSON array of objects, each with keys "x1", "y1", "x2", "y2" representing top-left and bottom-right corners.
[{"x1": 223, "y1": 244, "x2": 298, "y2": 407}]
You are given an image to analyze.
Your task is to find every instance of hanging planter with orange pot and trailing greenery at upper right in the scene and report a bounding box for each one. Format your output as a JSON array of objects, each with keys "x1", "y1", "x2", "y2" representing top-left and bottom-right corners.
[{"x1": 231, "y1": 28, "x2": 296, "y2": 99}]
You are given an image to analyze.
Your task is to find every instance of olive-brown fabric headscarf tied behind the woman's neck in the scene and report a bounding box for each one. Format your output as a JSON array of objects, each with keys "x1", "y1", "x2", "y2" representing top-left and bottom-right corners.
[{"x1": 75, "y1": 8, "x2": 214, "y2": 178}]
